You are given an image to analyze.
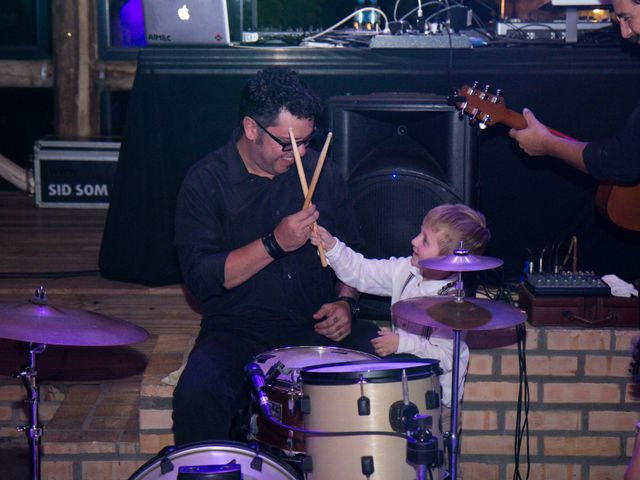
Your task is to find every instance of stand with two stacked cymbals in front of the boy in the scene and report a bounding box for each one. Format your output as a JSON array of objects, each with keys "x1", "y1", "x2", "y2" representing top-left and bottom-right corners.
[{"x1": 391, "y1": 245, "x2": 526, "y2": 480}]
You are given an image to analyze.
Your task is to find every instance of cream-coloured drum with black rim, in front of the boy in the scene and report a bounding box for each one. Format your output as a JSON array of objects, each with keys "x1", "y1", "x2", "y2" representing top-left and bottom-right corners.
[{"x1": 300, "y1": 360, "x2": 443, "y2": 480}]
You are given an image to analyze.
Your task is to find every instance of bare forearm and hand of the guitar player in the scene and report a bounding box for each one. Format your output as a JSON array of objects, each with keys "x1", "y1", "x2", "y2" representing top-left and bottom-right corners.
[{"x1": 509, "y1": 108, "x2": 588, "y2": 173}]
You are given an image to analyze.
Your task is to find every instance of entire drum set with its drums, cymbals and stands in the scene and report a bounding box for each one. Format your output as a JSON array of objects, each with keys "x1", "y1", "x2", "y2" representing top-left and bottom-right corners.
[{"x1": 0, "y1": 249, "x2": 526, "y2": 480}]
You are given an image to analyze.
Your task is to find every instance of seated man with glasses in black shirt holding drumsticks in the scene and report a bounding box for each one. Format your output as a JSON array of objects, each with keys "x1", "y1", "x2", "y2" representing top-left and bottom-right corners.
[{"x1": 173, "y1": 67, "x2": 377, "y2": 444}]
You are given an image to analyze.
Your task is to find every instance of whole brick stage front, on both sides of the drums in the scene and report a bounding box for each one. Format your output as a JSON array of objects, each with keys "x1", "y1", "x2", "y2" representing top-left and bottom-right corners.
[{"x1": 0, "y1": 326, "x2": 640, "y2": 480}]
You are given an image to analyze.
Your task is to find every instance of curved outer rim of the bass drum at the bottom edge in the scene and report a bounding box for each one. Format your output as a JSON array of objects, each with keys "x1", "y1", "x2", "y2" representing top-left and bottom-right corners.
[{"x1": 128, "y1": 440, "x2": 298, "y2": 480}]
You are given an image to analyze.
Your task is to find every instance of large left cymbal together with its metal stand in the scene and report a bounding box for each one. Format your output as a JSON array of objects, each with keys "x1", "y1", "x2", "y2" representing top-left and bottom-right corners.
[{"x1": 0, "y1": 286, "x2": 149, "y2": 480}]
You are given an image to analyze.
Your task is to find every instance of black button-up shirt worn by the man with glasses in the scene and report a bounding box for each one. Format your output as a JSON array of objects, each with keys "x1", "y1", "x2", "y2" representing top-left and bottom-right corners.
[{"x1": 176, "y1": 130, "x2": 359, "y2": 343}]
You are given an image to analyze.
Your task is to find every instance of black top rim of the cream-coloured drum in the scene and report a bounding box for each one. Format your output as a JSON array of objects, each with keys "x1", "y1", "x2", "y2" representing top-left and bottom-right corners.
[{"x1": 300, "y1": 358, "x2": 443, "y2": 384}]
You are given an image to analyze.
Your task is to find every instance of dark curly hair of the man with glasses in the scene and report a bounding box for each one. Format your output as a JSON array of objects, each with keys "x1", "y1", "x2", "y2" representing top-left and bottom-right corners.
[{"x1": 240, "y1": 67, "x2": 322, "y2": 126}]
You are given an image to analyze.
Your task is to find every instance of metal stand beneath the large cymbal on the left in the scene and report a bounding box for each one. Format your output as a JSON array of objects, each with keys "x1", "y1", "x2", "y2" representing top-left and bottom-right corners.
[{"x1": 16, "y1": 343, "x2": 46, "y2": 480}]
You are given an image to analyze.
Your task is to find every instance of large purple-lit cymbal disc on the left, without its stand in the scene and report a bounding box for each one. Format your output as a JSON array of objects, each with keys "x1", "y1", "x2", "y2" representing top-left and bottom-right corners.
[{"x1": 0, "y1": 302, "x2": 149, "y2": 346}]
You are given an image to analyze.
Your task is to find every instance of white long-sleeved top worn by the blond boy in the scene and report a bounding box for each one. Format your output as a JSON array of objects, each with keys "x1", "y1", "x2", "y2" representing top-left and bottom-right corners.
[{"x1": 326, "y1": 238, "x2": 469, "y2": 407}]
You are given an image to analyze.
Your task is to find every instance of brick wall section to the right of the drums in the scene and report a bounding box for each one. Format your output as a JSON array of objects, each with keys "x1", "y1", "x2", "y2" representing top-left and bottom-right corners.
[{"x1": 460, "y1": 326, "x2": 640, "y2": 480}]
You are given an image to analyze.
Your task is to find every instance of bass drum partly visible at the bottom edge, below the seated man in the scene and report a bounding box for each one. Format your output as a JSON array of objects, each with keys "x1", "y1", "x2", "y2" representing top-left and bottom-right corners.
[{"x1": 129, "y1": 442, "x2": 300, "y2": 480}]
